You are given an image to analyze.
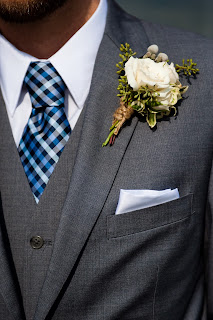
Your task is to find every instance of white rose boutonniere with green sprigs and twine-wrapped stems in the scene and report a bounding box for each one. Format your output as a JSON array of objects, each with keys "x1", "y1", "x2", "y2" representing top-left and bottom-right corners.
[{"x1": 102, "y1": 43, "x2": 199, "y2": 146}]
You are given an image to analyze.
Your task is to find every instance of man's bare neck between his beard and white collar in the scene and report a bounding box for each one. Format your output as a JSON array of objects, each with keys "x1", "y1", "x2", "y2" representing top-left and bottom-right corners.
[{"x1": 0, "y1": 0, "x2": 100, "y2": 59}]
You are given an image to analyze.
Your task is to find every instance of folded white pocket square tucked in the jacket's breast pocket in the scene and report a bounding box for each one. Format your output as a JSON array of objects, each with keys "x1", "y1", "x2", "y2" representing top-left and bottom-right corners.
[{"x1": 115, "y1": 188, "x2": 180, "y2": 214}]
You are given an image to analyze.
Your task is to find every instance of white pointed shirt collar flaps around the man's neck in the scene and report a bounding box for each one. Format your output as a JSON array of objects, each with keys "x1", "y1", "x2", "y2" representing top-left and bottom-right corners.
[{"x1": 0, "y1": 0, "x2": 107, "y2": 115}]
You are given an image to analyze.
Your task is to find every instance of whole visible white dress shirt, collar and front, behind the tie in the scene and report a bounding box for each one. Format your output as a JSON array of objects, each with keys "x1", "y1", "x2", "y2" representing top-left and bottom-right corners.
[{"x1": 0, "y1": 0, "x2": 107, "y2": 146}]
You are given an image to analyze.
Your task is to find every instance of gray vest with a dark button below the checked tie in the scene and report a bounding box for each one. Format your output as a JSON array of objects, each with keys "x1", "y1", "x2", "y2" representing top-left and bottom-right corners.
[{"x1": 0, "y1": 97, "x2": 84, "y2": 320}]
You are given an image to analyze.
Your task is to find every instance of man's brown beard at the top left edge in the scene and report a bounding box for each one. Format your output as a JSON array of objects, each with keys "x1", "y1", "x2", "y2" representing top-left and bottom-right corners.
[{"x1": 0, "y1": 0, "x2": 67, "y2": 23}]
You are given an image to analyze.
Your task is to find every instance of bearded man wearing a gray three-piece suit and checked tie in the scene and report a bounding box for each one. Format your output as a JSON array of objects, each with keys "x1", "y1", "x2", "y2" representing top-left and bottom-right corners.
[{"x1": 0, "y1": 0, "x2": 213, "y2": 320}]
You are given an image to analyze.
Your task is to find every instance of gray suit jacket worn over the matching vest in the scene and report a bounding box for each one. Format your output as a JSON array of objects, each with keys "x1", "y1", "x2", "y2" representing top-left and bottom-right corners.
[{"x1": 0, "y1": 1, "x2": 213, "y2": 320}]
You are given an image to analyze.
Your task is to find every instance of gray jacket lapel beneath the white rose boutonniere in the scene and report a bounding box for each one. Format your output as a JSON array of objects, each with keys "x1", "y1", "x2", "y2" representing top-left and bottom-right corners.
[{"x1": 34, "y1": 3, "x2": 148, "y2": 320}]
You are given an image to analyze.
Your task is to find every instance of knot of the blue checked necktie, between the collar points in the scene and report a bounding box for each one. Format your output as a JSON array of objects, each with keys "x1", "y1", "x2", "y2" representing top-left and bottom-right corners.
[{"x1": 24, "y1": 61, "x2": 66, "y2": 108}]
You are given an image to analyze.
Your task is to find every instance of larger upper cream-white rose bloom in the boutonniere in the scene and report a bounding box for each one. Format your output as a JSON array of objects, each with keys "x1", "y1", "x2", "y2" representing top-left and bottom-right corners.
[{"x1": 125, "y1": 57, "x2": 179, "y2": 91}]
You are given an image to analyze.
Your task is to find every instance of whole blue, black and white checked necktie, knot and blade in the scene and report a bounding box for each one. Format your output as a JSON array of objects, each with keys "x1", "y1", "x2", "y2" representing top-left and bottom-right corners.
[{"x1": 18, "y1": 61, "x2": 71, "y2": 203}]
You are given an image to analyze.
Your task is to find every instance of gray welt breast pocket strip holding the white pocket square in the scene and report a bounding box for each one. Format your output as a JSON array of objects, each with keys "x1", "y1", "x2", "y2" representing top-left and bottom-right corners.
[{"x1": 107, "y1": 193, "x2": 193, "y2": 238}]
